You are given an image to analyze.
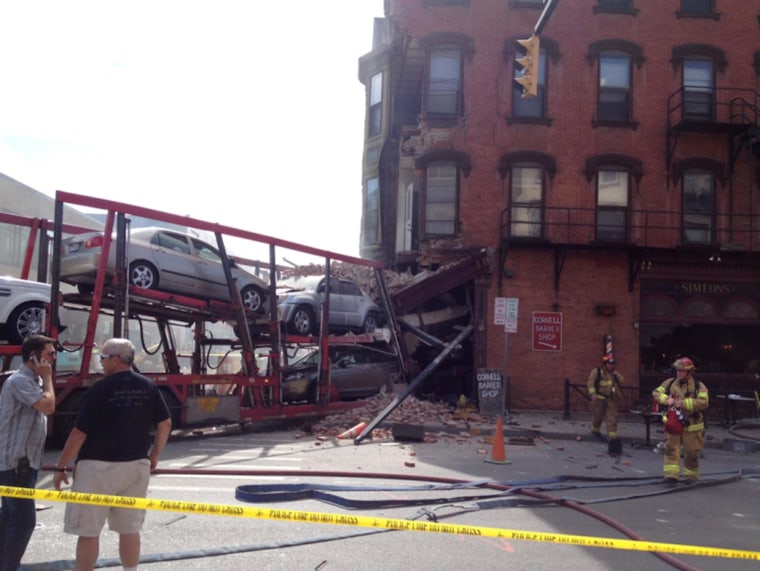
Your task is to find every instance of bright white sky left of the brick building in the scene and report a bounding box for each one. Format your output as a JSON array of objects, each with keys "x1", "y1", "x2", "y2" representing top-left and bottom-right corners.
[{"x1": 0, "y1": 0, "x2": 383, "y2": 262}]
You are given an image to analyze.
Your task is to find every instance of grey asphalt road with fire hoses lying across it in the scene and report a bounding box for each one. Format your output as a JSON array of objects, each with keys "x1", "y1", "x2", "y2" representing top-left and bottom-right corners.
[{"x1": 24, "y1": 424, "x2": 760, "y2": 571}]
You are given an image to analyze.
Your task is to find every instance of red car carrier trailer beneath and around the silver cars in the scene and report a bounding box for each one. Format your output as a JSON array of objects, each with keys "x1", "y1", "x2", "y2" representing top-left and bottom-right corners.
[{"x1": 40, "y1": 191, "x2": 407, "y2": 442}]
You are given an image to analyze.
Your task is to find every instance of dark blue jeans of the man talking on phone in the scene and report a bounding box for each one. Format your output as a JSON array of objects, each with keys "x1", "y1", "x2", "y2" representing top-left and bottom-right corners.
[{"x1": 0, "y1": 469, "x2": 37, "y2": 571}]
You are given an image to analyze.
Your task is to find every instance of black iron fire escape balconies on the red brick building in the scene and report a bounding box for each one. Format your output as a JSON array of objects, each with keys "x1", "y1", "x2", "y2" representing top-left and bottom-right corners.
[{"x1": 499, "y1": 88, "x2": 760, "y2": 300}]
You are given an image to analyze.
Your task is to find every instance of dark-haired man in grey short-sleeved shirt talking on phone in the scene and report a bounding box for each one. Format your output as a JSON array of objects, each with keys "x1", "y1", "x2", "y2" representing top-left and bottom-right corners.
[{"x1": 0, "y1": 335, "x2": 55, "y2": 571}]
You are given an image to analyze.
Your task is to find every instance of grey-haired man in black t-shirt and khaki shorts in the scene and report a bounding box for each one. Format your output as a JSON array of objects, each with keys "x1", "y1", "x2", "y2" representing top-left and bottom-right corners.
[{"x1": 54, "y1": 339, "x2": 172, "y2": 570}]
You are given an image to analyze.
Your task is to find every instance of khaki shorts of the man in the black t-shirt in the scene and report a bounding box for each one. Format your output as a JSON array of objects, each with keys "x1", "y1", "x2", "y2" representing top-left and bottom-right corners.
[{"x1": 63, "y1": 458, "x2": 150, "y2": 537}]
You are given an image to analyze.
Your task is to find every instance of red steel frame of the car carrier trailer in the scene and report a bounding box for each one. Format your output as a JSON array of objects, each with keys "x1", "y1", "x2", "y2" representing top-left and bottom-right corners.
[{"x1": 50, "y1": 191, "x2": 406, "y2": 441}]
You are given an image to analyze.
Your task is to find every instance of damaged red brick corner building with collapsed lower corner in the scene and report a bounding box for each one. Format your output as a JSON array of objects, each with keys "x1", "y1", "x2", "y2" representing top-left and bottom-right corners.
[{"x1": 359, "y1": 0, "x2": 760, "y2": 409}]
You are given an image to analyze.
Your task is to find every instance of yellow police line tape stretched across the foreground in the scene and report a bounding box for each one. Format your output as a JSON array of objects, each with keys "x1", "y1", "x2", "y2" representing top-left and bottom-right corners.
[{"x1": 5, "y1": 486, "x2": 760, "y2": 561}]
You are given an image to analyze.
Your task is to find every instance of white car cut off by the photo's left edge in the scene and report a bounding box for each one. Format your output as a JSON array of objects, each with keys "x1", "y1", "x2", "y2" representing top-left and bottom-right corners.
[{"x1": 0, "y1": 276, "x2": 50, "y2": 345}]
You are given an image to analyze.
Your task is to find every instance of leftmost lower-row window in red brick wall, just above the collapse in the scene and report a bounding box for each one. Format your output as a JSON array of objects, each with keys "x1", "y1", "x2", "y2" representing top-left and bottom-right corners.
[{"x1": 425, "y1": 162, "x2": 459, "y2": 236}]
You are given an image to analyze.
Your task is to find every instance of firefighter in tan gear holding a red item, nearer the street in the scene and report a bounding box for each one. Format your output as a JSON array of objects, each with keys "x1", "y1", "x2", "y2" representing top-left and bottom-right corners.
[{"x1": 652, "y1": 357, "x2": 710, "y2": 486}]
